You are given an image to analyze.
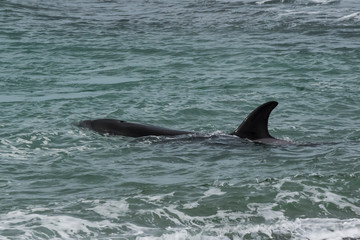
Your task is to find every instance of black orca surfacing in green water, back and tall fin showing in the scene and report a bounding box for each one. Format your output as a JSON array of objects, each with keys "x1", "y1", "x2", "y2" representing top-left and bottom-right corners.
[{"x1": 77, "y1": 101, "x2": 290, "y2": 145}]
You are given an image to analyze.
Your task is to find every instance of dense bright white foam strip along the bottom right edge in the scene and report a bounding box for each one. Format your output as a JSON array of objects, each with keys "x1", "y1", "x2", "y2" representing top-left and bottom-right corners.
[{"x1": 136, "y1": 218, "x2": 360, "y2": 240}]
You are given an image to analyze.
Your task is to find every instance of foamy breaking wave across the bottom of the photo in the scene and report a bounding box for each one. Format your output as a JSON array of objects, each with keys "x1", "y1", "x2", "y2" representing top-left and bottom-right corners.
[{"x1": 0, "y1": 179, "x2": 360, "y2": 240}]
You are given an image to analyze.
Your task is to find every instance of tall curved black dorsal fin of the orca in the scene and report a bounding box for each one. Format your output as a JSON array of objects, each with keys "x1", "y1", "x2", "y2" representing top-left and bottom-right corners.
[{"x1": 232, "y1": 101, "x2": 278, "y2": 140}]
